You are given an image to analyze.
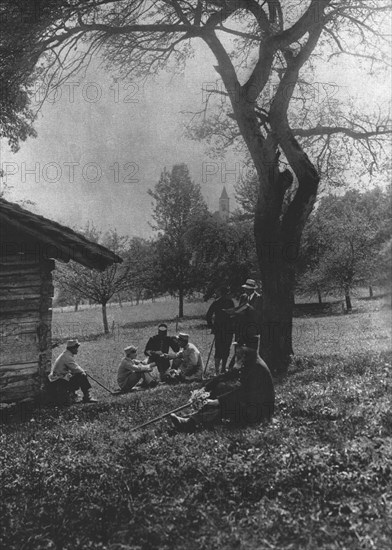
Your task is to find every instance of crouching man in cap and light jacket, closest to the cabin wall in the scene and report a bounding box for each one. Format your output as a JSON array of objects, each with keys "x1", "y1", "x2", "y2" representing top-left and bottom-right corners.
[{"x1": 48, "y1": 340, "x2": 97, "y2": 403}]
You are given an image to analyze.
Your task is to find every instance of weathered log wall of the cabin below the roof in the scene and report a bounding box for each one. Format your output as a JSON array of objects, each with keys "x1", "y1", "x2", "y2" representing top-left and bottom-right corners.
[{"x1": 0, "y1": 247, "x2": 54, "y2": 403}]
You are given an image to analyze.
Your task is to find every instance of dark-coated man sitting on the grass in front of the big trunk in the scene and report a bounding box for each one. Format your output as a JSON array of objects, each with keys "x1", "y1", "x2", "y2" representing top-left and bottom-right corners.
[{"x1": 170, "y1": 343, "x2": 275, "y2": 433}]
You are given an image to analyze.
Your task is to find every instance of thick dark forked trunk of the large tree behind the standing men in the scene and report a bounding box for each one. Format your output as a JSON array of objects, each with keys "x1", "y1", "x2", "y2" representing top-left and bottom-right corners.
[{"x1": 255, "y1": 164, "x2": 318, "y2": 377}]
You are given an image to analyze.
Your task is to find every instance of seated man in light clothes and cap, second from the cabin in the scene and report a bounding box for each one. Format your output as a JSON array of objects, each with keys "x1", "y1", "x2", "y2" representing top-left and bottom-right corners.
[{"x1": 117, "y1": 346, "x2": 158, "y2": 393}]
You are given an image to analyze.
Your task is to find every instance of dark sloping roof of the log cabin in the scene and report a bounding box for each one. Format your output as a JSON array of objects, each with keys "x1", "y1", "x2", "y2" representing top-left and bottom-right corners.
[{"x1": 0, "y1": 198, "x2": 122, "y2": 271}]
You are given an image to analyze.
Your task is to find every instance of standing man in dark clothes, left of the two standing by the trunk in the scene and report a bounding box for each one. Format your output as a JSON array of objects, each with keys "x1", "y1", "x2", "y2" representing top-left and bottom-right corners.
[{"x1": 206, "y1": 287, "x2": 234, "y2": 374}]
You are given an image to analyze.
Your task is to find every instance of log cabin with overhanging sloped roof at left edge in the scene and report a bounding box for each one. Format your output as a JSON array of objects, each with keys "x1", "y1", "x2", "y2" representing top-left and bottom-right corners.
[{"x1": 0, "y1": 199, "x2": 122, "y2": 403}]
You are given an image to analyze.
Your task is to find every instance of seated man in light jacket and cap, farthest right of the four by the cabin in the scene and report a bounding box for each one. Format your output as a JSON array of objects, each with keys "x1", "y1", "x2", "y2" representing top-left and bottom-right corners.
[{"x1": 167, "y1": 332, "x2": 204, "y2": 382}]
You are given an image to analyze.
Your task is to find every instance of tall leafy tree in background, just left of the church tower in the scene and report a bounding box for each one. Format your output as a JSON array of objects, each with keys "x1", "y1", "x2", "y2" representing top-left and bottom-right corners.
[{"x1": 148, "y1": 164, "x2": 207, "y2": 317}]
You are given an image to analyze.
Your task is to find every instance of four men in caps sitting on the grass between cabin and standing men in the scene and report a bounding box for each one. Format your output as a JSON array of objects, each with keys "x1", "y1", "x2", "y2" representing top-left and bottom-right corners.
[{"x1": 48, "y1": 323, "x2": 204, "y2": 403}]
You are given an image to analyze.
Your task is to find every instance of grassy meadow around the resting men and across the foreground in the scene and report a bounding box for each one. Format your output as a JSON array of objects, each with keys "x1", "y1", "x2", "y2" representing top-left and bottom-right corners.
[{"x1": 0, "y1": 300, "x2": 392, "y2": 550}]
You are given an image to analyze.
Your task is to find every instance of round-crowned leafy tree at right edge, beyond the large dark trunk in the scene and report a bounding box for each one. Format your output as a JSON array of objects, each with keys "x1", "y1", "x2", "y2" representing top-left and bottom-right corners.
[{"x1": 300, "y1": 188, "x2": 391, "y2": 311}]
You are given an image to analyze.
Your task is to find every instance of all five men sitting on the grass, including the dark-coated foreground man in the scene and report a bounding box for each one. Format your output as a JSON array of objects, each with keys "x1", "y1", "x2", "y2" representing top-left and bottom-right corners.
[{"x1": 49, "y1": 324, "x2": 275, "y2": 433}]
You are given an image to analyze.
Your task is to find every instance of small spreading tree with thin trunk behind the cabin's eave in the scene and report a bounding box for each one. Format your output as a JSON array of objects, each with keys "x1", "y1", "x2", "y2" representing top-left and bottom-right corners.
[{"x1": 56, "y1": 227, "x2": 130, "y2": 334}]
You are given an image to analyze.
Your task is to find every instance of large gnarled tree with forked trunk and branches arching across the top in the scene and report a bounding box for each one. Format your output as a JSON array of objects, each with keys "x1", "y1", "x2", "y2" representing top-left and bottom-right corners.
[{"x1": 2, "y1": 0, "x2": 390, "y2": 373}]
